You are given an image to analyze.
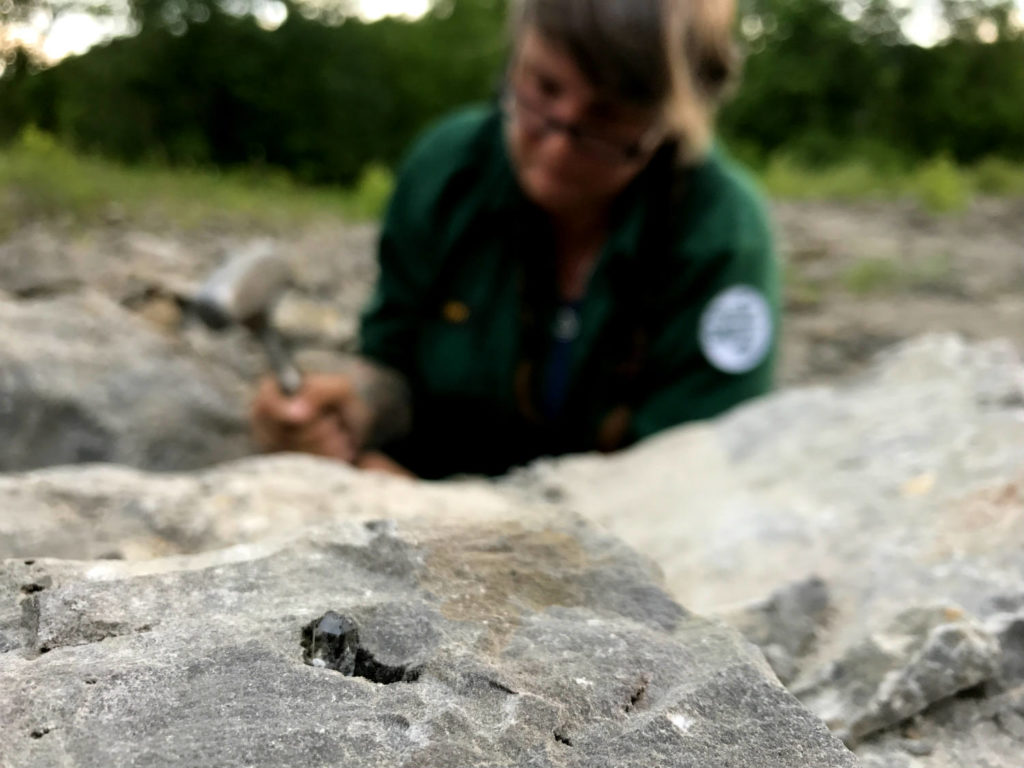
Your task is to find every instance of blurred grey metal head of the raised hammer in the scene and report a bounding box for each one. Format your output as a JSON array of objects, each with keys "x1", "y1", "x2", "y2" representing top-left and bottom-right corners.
[{"x1": 194, "y1": 241, "x2": 291, "y2": 330}]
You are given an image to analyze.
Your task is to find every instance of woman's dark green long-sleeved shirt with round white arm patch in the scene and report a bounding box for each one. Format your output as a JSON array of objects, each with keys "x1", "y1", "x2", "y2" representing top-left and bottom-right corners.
[{"x1": 360, "y1": 108, "x2": 778, "y2": 477}]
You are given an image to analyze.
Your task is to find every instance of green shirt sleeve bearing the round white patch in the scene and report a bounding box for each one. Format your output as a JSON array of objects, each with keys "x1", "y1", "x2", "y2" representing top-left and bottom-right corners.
[{"x1": 631, "y1": 171, "x2": 780, "y2": 439}]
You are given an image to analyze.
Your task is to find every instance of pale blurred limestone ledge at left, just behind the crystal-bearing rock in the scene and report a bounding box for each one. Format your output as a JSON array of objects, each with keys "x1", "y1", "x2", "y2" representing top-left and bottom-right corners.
[{"x1": 0, "y1": 455, "x2": 518, "y2": 560}]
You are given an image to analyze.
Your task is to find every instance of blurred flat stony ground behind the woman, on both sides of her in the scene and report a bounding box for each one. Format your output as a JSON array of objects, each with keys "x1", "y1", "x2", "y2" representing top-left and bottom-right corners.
[{"x1": 0, "y1": 200, "x2": 1024, "y2": 385}]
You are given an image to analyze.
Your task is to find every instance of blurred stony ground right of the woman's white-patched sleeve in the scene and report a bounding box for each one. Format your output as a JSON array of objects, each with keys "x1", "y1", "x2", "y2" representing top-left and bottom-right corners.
[{"x1": 775, "y1": 200, "x2": 1024, "y2": 384}]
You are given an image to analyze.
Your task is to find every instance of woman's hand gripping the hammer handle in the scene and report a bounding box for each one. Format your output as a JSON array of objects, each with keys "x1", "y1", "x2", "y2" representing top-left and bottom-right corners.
[{"x1": 250, "y1": 374, "x2": 374, "y2": 463}]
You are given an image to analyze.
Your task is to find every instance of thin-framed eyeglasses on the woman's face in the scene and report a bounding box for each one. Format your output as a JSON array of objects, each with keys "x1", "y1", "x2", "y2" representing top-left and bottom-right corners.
[{"x1": 502, "y1": 86, "x2": 662, "y2": 165}]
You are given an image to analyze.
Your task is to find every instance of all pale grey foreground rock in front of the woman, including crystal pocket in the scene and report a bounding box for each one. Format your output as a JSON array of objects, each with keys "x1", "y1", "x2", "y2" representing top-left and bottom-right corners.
[{"x1": 0, "y1": 336, "x2": 1024, "y2": 768}]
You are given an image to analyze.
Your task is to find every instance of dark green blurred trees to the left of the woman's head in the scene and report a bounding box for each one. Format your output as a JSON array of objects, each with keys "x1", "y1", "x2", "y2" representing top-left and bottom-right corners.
[{"x1": 0, "y1": 0, "x2": 505, "y2": 184}]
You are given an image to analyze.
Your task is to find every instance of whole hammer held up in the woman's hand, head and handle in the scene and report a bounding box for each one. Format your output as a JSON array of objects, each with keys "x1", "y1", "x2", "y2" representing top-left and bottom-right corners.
[{"x1": 193, "y1": 241, "x2": 302, "y2": 395}]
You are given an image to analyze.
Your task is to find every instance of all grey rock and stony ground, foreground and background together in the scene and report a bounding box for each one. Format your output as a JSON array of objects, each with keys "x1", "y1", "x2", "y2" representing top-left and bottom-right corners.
[{"x1": 0, "y1": 201, "x2": 1024, "y2": 768}]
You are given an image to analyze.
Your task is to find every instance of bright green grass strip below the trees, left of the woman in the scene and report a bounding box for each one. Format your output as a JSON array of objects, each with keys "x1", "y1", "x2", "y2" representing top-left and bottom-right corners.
[{"x1": 0, "y1": 130, "x2": 391, "y2": 234}]
